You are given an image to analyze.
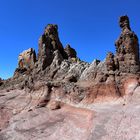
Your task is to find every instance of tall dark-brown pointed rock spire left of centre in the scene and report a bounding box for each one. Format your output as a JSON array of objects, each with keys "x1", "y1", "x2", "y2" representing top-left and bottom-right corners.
[{"x1": 38, "y1": 24, "x2": 64, "y2": 70}]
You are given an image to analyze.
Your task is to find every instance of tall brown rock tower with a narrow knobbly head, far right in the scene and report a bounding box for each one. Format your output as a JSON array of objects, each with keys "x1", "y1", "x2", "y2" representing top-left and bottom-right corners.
[{"x1": 115, "y1": 16, "x2": 140, "y2": 73}]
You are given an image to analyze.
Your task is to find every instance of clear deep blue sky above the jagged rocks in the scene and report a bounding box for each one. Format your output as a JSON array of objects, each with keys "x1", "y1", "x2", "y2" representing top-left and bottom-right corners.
[{"x1": 0, "y1": 0, "x2": 140, "y2": 78}]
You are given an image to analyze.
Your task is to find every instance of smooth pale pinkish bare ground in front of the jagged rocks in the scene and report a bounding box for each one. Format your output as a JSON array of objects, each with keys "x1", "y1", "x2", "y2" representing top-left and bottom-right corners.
[{"x1": 0, "y1": 87, "x2": 140, "y2": 140}]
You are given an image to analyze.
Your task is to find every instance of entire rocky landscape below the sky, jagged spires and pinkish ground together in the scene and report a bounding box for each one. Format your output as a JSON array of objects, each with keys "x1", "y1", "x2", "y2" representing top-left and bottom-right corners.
[{"x1": 0, "y1": 16, "x2": 140, "y2": 140}]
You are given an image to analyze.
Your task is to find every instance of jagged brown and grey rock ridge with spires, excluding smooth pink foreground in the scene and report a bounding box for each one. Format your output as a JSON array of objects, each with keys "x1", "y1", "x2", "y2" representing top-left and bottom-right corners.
[{"x1": 0, "y1": 16, "x2": 140, "y2": 104}]
